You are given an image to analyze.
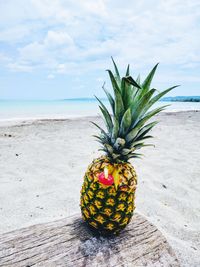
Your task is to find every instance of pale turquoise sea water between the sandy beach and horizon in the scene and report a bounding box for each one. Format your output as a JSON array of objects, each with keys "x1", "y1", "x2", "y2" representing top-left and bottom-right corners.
[{"x1": 0, "y1": 99, "x2": 200, "y2": 120}]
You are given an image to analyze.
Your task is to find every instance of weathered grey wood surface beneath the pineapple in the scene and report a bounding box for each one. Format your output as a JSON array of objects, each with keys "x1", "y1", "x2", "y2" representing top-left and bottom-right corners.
[{"x1": 0, "y1": 214, "x2": 180, "y2": 267}]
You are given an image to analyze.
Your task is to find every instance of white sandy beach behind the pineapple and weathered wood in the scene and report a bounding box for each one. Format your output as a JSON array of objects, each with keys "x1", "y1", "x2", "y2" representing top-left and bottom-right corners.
[{"x1": 0, "y1": 112, "x2": 200, "y2": 267}]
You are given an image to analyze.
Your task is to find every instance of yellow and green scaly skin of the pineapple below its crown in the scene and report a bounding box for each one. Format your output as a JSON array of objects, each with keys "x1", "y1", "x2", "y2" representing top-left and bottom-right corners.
[{"x1": 80, "y1": 157, "x2": 137, "y2": 235}]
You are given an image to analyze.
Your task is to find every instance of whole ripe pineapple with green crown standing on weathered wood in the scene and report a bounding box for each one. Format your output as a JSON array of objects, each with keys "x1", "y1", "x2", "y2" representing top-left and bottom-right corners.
[{"x1": 80, "y1": 58, "x2": 176, "y2": 235}]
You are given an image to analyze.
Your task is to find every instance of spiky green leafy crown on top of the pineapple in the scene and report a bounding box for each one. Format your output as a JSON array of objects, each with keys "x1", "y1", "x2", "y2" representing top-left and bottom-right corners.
[{"x1": 92, "y1": 58, "x2": 178, "y2": 163}]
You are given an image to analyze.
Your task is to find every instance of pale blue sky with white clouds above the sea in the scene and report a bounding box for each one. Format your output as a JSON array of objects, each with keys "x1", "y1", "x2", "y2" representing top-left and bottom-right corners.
[{"x1": 0, "y1": 0, "x2": 200, "y2": 99}]
